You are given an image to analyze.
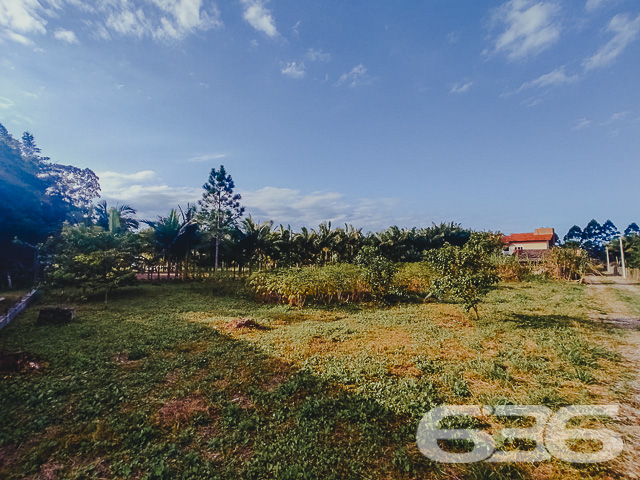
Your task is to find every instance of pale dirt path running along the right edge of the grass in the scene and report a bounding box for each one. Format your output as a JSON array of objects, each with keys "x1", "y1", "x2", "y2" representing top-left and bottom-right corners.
[{"x1": 587, "y1": 276, "x2": 640, "y2": 479}]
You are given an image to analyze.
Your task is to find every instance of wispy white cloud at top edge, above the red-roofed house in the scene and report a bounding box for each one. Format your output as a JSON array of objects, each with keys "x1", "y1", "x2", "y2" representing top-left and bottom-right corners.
[{"x1": 493, "y1": 0, "x2": 561, "y2": 60}]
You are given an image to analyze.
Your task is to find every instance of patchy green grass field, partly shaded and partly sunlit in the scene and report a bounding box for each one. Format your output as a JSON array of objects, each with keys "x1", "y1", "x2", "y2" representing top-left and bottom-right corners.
[{"x1": 0, "y1": 281, "x2": 629, "y2": 480}]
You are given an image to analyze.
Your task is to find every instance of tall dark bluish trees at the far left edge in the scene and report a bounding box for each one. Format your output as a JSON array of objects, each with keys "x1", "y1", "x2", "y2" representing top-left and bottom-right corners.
[{"x1": 0, "y1": 124, "x2": 100, "y2": 284}]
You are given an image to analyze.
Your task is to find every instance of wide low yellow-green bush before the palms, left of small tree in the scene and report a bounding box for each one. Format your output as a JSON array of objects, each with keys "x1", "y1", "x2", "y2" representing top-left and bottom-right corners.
[{"x1": 249, "y1": 264, "x2": 373, "y2": 306}]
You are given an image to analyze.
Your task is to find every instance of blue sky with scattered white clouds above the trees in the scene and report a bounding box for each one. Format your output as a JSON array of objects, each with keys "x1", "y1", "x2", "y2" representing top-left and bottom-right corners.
[{"x1": 0, "y1": 0, "x2": 640, "y2": 235}]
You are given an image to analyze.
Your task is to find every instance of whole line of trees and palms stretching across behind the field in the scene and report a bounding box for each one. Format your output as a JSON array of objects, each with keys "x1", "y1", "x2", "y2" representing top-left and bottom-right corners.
[{"x1": 0, "y1": 119, "x2": 640, "y2": 308}]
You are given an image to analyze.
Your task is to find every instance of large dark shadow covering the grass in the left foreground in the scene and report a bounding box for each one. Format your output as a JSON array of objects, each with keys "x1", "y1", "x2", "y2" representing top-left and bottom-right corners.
[{"x1": 0, "y1": 286, "x2": 624, "y2": 480}]
